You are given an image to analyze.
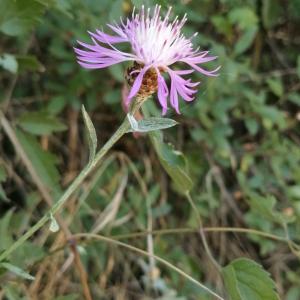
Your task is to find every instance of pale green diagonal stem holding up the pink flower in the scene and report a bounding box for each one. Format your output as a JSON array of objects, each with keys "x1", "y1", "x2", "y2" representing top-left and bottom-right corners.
[{"x1": 0, "y1": 117, "x2": 130, "y2": 262}]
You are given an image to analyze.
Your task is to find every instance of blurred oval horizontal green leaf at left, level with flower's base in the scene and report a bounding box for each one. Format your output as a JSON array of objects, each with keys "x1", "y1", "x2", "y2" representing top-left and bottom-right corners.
[{"x1": 18, "y1": 111, "x2": 67, "y2": 135}]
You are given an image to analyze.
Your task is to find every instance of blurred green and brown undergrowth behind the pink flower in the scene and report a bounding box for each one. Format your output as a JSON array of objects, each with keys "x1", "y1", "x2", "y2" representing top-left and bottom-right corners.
[{"x1": 0, "y1": 0, "x2": 300, "y2": 300}]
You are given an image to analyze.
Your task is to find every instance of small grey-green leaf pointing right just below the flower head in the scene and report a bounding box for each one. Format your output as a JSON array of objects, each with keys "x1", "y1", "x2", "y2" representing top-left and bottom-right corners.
[{"x1": 130, "y1": 118, "x2": 178, "y2": 132}]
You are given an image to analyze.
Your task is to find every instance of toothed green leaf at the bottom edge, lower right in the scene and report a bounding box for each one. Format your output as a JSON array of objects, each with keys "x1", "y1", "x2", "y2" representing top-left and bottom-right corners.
[{"x1": 222, "y1": 258, "x2": 279, "y2": 300}]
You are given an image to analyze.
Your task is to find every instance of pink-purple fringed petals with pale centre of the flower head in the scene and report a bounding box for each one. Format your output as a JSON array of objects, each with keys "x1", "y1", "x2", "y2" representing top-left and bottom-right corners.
[{"x1": 74, "y1": 5, "x2": 219, "y2": 114}]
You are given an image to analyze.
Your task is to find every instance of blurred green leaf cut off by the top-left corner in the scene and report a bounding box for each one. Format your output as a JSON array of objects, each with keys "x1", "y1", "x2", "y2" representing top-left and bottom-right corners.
[{"x1": 0, "y1": 0, "x2": 46, "y2": 36}]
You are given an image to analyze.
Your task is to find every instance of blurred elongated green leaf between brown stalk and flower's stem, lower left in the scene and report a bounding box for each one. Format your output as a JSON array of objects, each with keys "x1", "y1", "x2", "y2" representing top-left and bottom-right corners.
[{"x1": 16, "y1": 130, "x2": 60, "y2": 197}]
